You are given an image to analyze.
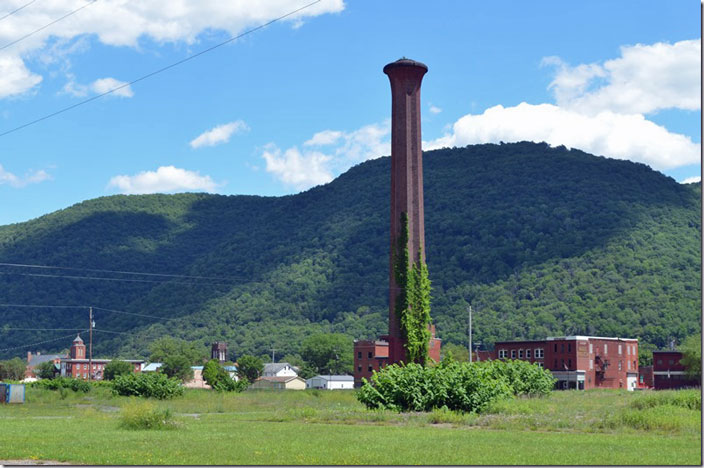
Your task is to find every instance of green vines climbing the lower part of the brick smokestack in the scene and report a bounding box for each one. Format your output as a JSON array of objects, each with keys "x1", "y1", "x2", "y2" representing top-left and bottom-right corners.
[{"x1": 394, "y1": 212, "x2": 430, "y2": 364}]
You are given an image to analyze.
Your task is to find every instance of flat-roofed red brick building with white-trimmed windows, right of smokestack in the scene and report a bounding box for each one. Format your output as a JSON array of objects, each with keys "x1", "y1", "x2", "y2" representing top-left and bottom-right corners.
[{"x1": 492, "y1": 336, "x2": 638, "y2": 390}]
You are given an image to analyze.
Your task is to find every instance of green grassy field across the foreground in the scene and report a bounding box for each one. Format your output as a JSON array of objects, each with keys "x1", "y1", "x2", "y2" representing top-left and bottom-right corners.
[{"x1": 0, "y1": 388, "x2": 702, "y2": 465}]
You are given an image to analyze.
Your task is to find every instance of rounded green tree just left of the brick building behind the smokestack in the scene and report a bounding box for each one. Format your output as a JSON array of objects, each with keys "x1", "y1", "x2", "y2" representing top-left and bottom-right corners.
[{"x1": 301, "y1": 333, "x2": 354, "y2": 374}]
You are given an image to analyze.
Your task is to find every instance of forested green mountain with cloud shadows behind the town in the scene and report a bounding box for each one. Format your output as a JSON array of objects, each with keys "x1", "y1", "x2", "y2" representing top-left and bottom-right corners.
[{"x1": 0, "y1": 143, "x2": 701, "y2": 357}]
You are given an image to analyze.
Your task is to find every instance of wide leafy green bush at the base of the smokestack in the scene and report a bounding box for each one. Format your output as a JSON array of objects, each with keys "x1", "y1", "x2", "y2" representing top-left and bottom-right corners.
[{"x1": 357, "y1": 360, "x2": 554, "y2": 413}]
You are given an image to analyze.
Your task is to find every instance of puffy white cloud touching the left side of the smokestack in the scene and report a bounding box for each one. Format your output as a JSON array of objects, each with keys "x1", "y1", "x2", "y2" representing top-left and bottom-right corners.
[{"x1": 262, "y1": 120, "x2": 391, "y2": 190}]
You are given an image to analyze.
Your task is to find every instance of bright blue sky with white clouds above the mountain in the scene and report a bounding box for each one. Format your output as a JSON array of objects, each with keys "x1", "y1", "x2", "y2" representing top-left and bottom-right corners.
[{"x1": 0, "y1": 0, "x2": 701, "y2": 224}]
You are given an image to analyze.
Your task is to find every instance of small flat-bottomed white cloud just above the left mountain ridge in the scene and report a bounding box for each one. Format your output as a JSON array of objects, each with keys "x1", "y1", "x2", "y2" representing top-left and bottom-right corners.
[{"x1": 108, "y1": 166, "x2": 218, "y2": 194}]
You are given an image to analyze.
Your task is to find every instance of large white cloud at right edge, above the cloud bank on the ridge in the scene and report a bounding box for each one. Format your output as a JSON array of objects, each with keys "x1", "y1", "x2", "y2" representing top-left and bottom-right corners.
[{"x1": 543, "y1": 39, "x2": 701, "y2": 114}]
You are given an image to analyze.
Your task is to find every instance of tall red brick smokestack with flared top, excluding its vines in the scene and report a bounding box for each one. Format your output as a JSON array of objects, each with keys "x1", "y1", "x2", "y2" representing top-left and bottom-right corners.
[{"x1": 384, "y1": 58, "x2": 428, "y2": 362}]
